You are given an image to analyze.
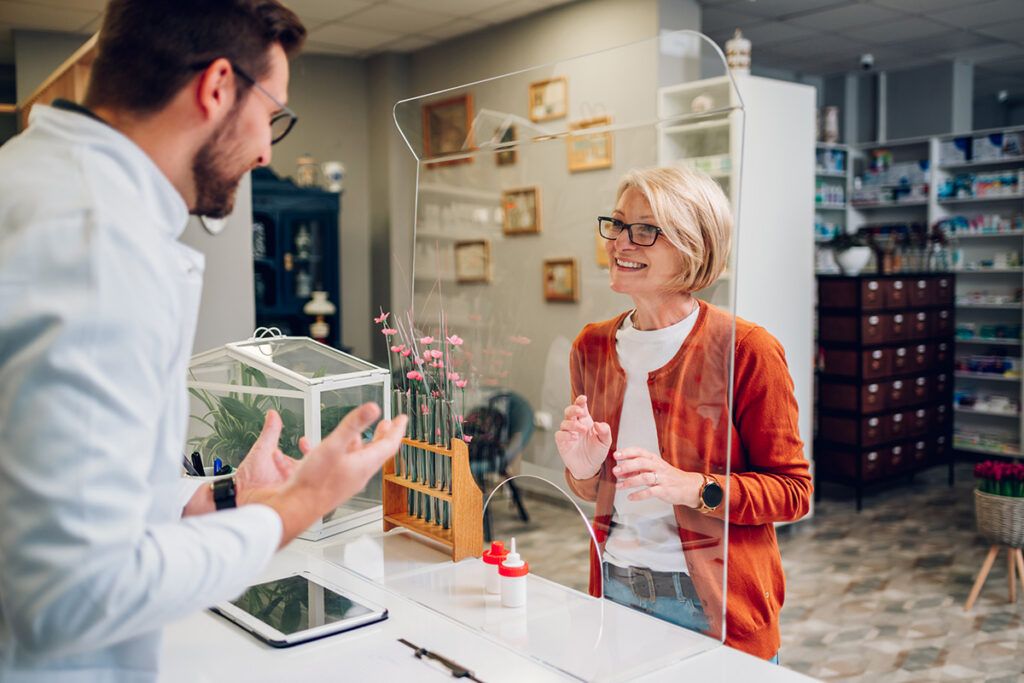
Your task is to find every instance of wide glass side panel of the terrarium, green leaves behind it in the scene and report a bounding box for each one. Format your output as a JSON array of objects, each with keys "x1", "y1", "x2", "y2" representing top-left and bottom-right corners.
[{"x1": 188, "y1": 387, "x2": 305, "y2": 467}]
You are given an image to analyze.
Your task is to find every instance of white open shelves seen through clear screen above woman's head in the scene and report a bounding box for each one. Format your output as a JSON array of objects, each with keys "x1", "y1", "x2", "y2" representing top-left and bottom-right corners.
[{"x1": 657, "y1": 76, "x2": 742, "y2": 205}]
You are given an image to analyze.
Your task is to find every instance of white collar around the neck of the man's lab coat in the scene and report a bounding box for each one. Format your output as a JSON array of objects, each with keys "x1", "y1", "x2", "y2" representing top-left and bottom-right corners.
[{"x1": 29, "y1": 104, "x2": 188, "y2": 240}]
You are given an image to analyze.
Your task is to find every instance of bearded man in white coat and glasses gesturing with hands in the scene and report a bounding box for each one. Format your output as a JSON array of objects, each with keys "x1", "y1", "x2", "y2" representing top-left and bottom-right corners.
[{"x1": 0, "y1": 0, "x2": 404, "y2": 681}]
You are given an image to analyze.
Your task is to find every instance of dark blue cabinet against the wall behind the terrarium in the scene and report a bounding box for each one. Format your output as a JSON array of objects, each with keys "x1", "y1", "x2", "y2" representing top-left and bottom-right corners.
[{"x1": 253, "y1": 168, "x2": 341, "y2": 348}]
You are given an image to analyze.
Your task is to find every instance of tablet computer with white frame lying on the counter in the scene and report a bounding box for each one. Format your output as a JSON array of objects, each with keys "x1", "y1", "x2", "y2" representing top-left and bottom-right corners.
[{"x1": 211, "y1": 571, "x2": 387, "y2": 647}]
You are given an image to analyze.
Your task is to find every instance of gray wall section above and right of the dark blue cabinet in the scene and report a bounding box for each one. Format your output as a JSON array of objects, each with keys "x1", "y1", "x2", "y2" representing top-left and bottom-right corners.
[{"x1": 271, "y1": 55, "x2": 372, "y2": 357}]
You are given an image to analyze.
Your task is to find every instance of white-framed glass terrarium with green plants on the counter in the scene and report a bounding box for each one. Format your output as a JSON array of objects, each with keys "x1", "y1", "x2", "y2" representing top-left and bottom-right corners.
[{"x1": 187, "y1": 336, "x2": 391, "y2": 541}]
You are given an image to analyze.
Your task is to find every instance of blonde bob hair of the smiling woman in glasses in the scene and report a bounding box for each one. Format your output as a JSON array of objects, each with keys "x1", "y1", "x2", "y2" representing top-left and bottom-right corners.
[{"x1": 615, "y1": 166, "x2": 732, "y2": 293}]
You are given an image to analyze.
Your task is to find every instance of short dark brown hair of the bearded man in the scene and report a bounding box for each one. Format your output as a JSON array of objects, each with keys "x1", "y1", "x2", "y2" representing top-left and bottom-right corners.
[{"x1": 85, "y1": 0, "x2": 306, "y2": 114}]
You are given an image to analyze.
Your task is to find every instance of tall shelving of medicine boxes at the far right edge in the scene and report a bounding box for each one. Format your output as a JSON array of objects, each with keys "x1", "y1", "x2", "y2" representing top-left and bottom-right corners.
[{"x1": 929, "y1": 127, "x2": 1024, "y2": 457}]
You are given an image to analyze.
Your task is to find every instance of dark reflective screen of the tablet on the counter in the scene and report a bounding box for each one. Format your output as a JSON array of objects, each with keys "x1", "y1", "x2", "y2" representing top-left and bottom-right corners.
[{"x1": 231, "y1": 575, "x2": 372, "y2": 635}]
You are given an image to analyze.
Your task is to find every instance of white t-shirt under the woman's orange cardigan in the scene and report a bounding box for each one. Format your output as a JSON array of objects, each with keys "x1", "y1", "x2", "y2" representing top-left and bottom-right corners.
[{"x1": 604, "y1": 305, "x2": 699, "y2": 572}]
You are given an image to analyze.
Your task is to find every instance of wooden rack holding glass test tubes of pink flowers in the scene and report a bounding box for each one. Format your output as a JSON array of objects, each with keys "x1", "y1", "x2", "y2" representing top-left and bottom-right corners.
[{"x1": 383, "y1": 438, "x2": 483, "y2": 562}]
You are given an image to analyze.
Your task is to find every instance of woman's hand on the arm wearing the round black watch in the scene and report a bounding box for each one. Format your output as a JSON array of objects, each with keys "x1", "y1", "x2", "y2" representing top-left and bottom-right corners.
[{"x1": 611, "y1": 447, "x2": 703, "y2": 508}]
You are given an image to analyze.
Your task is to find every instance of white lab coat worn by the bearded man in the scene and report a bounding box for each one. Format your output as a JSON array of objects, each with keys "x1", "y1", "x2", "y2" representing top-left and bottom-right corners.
[{"x1": 0, "y1": 106, "x2": 282, "y2": 682}]
